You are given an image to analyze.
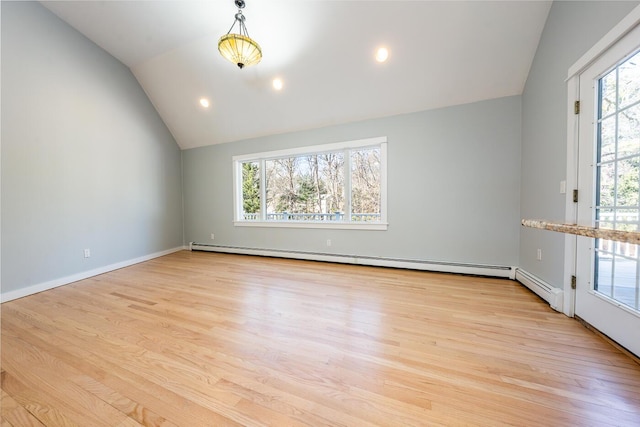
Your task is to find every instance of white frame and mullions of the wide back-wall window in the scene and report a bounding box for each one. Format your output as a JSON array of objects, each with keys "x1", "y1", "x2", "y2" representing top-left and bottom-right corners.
[{"x1": 232, "y1": 136, "x2": 388, "y2": 230}]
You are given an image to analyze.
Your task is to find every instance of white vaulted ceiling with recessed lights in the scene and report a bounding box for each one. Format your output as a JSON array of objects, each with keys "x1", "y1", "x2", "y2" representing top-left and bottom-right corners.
[{"x1": 42, "y1": 0, "x2": 551, "y2": 149}]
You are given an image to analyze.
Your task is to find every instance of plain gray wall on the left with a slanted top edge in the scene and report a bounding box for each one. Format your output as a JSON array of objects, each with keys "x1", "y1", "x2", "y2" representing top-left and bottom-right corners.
[{"x1": 1, "y1": 2, "x2": 183, "y2": 293}]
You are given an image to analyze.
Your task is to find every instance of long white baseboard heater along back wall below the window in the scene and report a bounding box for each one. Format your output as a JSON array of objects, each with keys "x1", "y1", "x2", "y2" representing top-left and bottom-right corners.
[{"x1": 189, "y1": 242, "x2": 515, "y2": 280}]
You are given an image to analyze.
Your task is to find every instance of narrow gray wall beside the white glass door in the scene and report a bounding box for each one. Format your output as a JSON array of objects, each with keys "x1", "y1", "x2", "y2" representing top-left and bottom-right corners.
[{"x1": 519, "y1": 1, "x2": 638, "y2": 287}]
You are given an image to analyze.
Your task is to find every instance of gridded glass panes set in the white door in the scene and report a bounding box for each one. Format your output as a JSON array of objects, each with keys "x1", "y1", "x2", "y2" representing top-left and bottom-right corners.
[{"x1": 594, "y1": 52, "x2": 640, "y2": 311}]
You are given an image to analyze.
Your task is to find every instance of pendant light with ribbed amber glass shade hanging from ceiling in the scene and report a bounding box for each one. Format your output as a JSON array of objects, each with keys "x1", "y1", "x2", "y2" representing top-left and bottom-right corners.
[{"x1": 218, "y1": 0, "x2": 262, "y2": 69}]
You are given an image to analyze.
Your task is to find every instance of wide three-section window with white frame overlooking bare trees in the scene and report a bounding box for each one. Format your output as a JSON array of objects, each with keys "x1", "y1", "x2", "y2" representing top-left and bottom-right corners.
[{"x1": 233, "y1": 137, "x2": 387, "y2": 230}]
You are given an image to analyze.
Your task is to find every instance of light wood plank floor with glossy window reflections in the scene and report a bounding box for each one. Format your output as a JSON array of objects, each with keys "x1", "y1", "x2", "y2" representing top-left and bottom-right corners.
[{"x1": 1, "y1": 251, "x2": 640, "y2": 427}]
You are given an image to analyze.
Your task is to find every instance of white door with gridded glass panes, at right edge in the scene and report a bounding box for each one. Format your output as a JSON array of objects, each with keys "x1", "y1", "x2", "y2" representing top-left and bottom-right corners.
[{"x1": 575, "y1": 26, "x2": 640, "y2": 356}]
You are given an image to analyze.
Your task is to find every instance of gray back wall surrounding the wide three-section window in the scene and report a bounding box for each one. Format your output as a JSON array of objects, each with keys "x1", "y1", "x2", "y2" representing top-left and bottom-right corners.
[{"x1": 183, "y1": 96, "x2": 521, "y2": 266}]
